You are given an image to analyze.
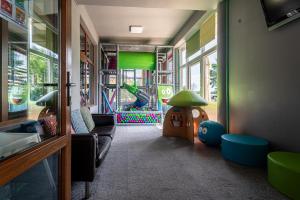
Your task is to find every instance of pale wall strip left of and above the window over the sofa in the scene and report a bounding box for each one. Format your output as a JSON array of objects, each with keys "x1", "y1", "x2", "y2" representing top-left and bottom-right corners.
[{"x1": 71, "y1": 0, "x2": 99, "y2": 110}]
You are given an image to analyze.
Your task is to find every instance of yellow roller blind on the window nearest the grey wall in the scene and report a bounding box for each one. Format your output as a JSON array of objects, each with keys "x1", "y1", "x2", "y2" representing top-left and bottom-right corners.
[{"x1": 200, "y1": 14, "x2": 216, "y2": 48}]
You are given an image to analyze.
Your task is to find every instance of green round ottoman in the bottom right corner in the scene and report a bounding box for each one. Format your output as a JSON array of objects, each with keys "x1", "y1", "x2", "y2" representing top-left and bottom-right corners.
[{"x1": 268, "y1": 152, "x2": 300, "y2": 200}]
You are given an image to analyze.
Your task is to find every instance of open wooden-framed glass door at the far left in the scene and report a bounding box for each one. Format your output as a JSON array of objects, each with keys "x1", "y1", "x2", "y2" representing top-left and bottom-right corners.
[{"x1": 0, "y1": 0, "x2": 70, "y2": 200}]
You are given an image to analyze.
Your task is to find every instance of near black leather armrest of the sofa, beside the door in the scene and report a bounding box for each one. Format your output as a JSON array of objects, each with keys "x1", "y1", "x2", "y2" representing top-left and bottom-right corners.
[{"x1": 72, "y1": 133, "x2": 98, "y2": 182}]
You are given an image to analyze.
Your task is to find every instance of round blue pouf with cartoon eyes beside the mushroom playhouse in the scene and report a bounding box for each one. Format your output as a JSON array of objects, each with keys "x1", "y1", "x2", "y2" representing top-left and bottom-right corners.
[{"x1": 198, "y1": 120, "x2": 225, "y2": 145}]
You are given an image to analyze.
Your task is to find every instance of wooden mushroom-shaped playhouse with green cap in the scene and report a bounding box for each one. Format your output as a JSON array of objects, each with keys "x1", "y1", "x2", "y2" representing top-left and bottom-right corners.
[{"x1": 163, "y1": 90, "x2": 208, "y2": 143}]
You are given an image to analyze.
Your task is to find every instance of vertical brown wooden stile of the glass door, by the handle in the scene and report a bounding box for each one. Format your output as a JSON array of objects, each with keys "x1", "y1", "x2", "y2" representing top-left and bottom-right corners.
[{"x1": 59, "y1": 0, "x2": 72, "y2": 200}]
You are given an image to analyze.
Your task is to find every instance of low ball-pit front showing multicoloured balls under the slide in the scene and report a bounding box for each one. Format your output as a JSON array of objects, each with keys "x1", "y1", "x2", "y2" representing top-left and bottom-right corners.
[{"x1": 116, "y1": 111, "x2": 162, "y2": 124}]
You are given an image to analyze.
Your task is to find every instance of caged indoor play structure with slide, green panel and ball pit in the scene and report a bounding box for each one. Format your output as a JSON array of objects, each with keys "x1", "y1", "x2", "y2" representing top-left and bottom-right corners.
[{"x1": 99, "y1": 43, "x2": 176, "y2": 125}]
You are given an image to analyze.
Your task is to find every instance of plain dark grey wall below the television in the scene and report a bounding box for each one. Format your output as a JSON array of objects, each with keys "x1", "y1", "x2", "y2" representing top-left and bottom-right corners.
[{"x1": 229, "y1": 0, "x2": 300, "y2": 151}]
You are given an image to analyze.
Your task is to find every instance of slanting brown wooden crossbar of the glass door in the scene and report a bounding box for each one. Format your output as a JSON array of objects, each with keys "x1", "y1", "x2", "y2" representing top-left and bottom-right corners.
[{"x1": 0, "y1": 136, "x2": 68, "y2": 186}]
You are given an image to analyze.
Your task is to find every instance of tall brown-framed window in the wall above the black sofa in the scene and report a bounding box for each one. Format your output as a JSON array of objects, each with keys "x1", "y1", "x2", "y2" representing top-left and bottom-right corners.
[{"x1": 80, "y1": 26, "x2": 96, "y2": 106}]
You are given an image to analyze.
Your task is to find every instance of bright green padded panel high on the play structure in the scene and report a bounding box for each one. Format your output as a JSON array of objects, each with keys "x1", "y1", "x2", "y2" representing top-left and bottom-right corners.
[{"x1": 118, "y1": 51, "x2": 156, "y2": 71}]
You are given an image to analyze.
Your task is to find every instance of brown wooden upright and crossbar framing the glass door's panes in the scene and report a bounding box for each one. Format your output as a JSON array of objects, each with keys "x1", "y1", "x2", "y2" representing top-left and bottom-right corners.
[{"x1": 0, "y1": 0, "x2": 72, "y2": 200}]
